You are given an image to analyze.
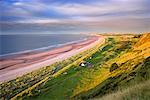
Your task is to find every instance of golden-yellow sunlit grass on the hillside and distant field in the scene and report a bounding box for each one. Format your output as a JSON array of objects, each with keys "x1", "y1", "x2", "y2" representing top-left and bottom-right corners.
[{"x1": 72, "y1": 34, "x2": 150, "y2": 100}]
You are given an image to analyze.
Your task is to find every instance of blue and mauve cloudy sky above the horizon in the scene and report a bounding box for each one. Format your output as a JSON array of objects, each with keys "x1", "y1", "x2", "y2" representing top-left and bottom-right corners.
[{"x1": 0, "y1": 0, "x2": 150, "y2": 34}]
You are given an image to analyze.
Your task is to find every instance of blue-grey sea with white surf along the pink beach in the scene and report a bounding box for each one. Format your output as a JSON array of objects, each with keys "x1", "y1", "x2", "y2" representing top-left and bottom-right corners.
[{"x1": 0, "y1": 34, "x2": 89, "y2": 57}]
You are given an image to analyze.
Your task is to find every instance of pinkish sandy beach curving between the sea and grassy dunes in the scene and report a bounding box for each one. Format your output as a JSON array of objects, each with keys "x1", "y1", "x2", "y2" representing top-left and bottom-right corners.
[{"x1": 0, "y1": 36, "x2": 104, "y2": 82}]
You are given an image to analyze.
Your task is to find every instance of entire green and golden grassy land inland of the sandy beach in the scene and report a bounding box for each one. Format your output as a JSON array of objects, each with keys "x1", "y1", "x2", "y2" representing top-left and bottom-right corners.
[{"x1": 1, "y1": 33, "x2": 150, "y2": 100}]
